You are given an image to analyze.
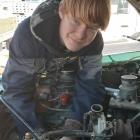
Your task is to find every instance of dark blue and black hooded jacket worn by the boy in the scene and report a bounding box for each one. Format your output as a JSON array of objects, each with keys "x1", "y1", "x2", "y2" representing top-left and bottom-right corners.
[{"x1": 2, "y1": 0, "x2": 105, "y2": 135}]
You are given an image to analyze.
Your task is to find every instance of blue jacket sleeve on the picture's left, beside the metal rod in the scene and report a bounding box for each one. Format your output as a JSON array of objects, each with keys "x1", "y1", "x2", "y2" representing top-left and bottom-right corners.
[{"x1": 2, "y1": 18, "x2": 45, "y2": 131}]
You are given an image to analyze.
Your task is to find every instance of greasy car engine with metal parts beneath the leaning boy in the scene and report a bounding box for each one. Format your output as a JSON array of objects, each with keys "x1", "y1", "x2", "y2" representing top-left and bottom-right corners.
[{"x1": 1, "y1": 57, "x2": 140, "y2": 140}]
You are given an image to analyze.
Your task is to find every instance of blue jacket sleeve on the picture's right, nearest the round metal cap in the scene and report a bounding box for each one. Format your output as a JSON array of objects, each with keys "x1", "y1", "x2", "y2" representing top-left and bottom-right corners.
[{"x1": 71, "y1": 55, "x2": 105, "y2": 122}]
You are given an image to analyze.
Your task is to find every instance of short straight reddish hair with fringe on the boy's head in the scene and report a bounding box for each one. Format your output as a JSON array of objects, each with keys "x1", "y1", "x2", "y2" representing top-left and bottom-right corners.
[{"x1": 60, "y1": 0, "x2": 111, "y2": 30}]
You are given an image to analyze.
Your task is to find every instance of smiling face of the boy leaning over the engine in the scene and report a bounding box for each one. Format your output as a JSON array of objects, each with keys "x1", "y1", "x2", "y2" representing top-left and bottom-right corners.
[{"x1": 59, "y1": 6, "x2": 98, "y2": 52}]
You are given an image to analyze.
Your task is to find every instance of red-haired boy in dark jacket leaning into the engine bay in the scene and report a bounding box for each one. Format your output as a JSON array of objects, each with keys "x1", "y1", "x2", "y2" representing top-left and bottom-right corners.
[{"x1": 2, "y1": 0, "x2": 110, "y2": 139}]
